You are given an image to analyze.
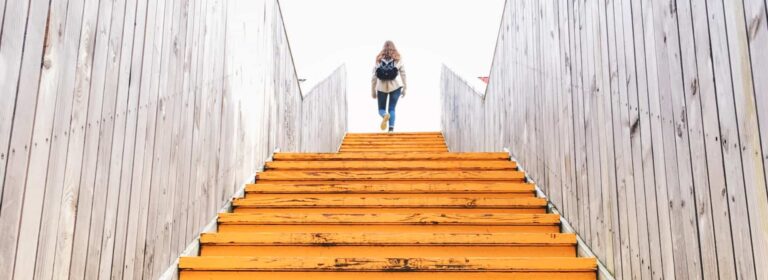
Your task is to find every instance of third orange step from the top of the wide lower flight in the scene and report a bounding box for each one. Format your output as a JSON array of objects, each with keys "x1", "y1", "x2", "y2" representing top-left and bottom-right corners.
[{"x1": 256, "y1": 170, "x2": 525, "y2": 182}]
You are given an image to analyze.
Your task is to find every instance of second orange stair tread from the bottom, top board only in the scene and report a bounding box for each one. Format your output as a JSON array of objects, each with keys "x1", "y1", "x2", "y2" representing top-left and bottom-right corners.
[{"x1": 200, "y1": 232, "x2": 576, "y2": 246}]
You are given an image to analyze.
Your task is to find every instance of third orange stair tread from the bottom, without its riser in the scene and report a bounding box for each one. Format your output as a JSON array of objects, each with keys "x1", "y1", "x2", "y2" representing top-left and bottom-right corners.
[{"x1": 218, "y1": 213, "x2": 560, "y2": 225}]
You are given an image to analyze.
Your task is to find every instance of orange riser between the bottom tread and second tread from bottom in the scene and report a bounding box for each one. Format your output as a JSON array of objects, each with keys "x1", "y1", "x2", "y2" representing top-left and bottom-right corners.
[{"x1": 200, "y1": 245, "x2": 576, "y2": 258}]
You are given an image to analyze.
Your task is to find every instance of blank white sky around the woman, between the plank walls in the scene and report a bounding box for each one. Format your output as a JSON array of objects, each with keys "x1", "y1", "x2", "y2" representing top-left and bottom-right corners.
[{"x1": 280, "y1": 0, "x2": 504, "y2": 132}]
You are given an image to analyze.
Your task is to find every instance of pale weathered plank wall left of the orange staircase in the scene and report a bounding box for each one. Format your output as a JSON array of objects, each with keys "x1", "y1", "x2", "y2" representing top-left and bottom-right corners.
[{"x1": 0, "y1": 0, "x2": 346, "y2": 279}]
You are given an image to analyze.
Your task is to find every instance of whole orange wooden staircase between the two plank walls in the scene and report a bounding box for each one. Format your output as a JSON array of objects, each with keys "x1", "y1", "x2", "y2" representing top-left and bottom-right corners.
[{"x1": 179, "y1": 133, "x2": 596, "y2": 280}]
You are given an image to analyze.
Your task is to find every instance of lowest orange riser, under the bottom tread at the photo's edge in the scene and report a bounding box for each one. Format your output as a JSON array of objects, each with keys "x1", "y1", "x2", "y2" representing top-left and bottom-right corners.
[{"x1": 179, "y1": 271, "x2": 595, "y2": 280}]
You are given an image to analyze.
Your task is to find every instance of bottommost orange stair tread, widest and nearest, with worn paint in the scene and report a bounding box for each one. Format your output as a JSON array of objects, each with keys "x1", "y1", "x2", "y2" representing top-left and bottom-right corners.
[{"x1": 179, "y1": 256, "x2": 597, "y2": 272}]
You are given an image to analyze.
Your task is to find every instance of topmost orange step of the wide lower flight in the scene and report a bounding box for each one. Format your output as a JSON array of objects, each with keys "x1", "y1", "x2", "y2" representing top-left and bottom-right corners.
[{"x1": 273, "y1": 152, "x2": 509, "y2": 161}]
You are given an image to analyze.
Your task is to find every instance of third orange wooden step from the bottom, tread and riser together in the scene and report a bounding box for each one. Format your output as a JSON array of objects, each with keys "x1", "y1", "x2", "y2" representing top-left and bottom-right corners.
[{"x1": 218, "y1": 210, "x2": 560, "y2": 233}]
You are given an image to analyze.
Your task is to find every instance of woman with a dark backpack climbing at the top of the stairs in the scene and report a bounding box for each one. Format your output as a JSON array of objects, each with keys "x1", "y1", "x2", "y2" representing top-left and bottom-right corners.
[{"x1": 371, "y1": 41, "x2": 406, "y2": 132}]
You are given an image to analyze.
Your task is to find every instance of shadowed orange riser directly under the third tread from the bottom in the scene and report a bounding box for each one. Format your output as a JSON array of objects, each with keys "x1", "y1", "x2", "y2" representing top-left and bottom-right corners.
[{"x1": 218, "y1": 224, "x2": 560, "y2": 233}]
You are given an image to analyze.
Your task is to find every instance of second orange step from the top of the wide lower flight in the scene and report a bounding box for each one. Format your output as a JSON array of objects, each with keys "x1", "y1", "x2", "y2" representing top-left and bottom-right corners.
[{"x1": 266, "y1": 160, "x2": 517, "y2": 170}]
